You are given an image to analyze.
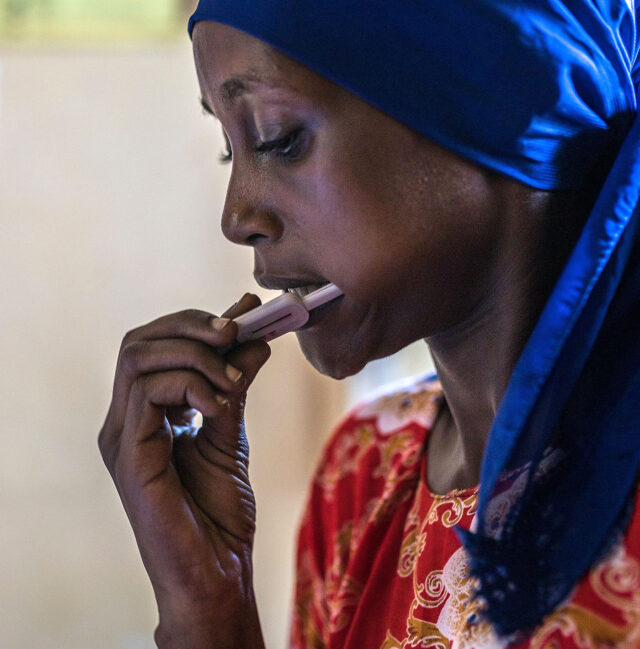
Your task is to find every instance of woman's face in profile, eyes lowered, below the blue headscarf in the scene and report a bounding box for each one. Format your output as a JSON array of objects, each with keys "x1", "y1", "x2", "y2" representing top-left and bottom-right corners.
[{"x1": 193, "y1": 22, "x2": 501, "y2": 378}]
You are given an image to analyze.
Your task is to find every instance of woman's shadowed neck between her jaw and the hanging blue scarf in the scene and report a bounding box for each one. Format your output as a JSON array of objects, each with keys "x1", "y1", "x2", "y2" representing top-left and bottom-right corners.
[{"x1": 426, "y1": 185, "x2": 580, "y2": 493}]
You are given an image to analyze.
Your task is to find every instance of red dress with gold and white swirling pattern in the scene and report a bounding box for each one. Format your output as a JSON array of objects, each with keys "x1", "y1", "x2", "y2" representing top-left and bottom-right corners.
[{"x1": 291, "y1": 380, "x2": 640, "y2": 649}]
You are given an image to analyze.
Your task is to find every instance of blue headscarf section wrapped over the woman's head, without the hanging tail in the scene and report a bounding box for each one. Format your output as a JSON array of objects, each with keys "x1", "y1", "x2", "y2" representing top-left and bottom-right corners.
[{"x1": 189, "y1": 0, "x2": 640, "y2": 189}]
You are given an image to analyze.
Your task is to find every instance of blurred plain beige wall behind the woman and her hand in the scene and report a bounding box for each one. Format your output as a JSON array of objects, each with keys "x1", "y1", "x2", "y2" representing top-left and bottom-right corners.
[{"x1": 0, "y1": 39, "x2": 432, "y2": 649}]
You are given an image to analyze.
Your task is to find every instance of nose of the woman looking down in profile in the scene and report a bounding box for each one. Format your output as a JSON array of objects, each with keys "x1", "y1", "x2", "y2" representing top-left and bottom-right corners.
[{"x1": 222, "y1": 174, "x2": 282, "y2": 246}]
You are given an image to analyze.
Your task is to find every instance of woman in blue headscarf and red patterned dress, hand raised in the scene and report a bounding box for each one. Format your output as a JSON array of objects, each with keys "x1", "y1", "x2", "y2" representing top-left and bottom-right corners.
[{"x1": 100, "y1": 0, "x2": 640, "y2": 649}]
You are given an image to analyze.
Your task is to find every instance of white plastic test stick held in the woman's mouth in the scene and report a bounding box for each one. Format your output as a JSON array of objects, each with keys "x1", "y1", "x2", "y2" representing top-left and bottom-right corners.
[{"x1": 234, "y1": 284, "x2": 342, "y2": 343}]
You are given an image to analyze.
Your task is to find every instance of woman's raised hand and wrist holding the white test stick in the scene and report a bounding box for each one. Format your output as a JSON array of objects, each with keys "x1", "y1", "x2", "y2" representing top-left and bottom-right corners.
[{"x1": 99, "y1": 295, "x2": 269, "y2": 649}]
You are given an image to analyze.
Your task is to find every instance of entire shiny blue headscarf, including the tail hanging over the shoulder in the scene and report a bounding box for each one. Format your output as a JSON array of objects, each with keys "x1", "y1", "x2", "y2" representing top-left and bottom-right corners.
[{"x1": 189, "y1": 0, "x2": 640, "y2": 638}]
